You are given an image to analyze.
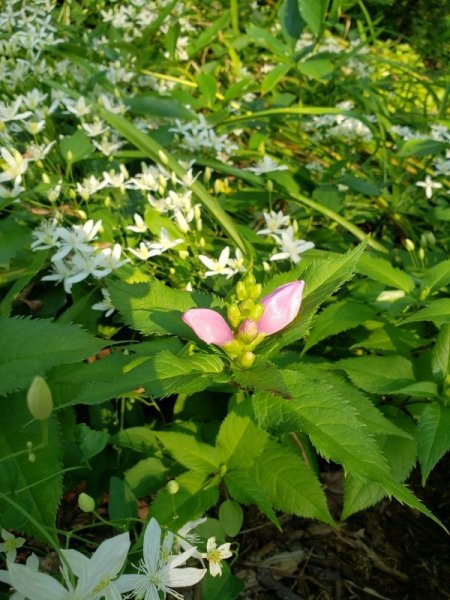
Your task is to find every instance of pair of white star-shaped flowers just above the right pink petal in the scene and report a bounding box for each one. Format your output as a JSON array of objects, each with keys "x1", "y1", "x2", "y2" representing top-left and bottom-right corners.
[{"x1": 257, "y1": 210, "x2": 314, "y2": 264}]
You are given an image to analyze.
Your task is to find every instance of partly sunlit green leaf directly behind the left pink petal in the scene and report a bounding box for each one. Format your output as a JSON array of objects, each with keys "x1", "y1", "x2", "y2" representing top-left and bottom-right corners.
[{"x1": 108, "y1": 280, "x2": 223, "y2": 341}]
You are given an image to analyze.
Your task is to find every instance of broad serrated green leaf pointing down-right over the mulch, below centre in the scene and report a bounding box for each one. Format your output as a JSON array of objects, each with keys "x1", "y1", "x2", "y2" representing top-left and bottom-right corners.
[{"x1": 250, "y1": 442, "x2": 334, "y2": 525}]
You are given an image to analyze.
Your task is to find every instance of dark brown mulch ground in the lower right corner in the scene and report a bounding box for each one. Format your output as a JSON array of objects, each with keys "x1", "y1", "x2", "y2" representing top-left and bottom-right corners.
[{"x1": 233, "y1": 457, "x2": 450, "y2": 600}]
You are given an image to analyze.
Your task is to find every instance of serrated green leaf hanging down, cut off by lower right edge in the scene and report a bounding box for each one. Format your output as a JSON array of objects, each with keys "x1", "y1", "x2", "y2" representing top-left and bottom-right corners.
[{"x1": 417, "y1": 402, "x2": 450, "y2": 485}]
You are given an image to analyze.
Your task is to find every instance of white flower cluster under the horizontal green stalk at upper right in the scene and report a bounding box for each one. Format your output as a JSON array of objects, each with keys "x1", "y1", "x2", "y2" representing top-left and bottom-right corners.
[{"x1": 303, "y1": 101, "x2": 374, "y2": 142}]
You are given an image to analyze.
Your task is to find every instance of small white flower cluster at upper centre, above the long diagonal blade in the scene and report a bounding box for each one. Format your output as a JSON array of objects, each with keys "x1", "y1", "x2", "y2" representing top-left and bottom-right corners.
[{"x1": 170, "y1": 114, "x2": 238, "y2": 162}]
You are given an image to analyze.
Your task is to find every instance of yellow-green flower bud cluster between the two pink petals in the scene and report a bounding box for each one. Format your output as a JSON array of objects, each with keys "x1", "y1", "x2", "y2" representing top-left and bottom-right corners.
[{"x1": 223, "y1": 273, "x2": 264, "y2": 369}]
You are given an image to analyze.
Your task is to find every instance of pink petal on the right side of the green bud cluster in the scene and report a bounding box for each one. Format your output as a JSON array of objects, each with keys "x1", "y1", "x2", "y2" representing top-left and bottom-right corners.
[{"x1": 257, "y1": 281, "x2": 305, "y2": 335}]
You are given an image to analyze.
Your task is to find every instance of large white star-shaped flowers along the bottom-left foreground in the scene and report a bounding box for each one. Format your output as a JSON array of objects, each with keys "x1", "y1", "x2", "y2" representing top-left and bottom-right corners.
[{"x1": 0, "y1": 518, "x2": 232, "y2": 600}]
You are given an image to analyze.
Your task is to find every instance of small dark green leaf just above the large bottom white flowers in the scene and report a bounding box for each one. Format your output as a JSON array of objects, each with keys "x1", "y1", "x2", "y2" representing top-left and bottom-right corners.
[{"x1": 150, "y1": 471, "x2": 219, "y2": 531}]
